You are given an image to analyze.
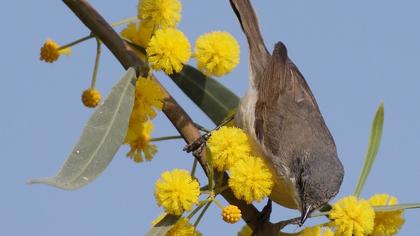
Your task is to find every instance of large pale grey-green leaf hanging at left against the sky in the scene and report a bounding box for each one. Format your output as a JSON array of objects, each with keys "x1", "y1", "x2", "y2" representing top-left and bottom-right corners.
[{"x1": 29, "y1": 68, "x2": 136, "y2": 190}]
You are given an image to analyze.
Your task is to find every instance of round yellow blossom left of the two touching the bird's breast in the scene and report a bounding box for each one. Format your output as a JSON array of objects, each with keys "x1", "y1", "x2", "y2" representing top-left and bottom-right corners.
[{"x1": 155, "y1": 169, "x2": 200, "y2": 215}]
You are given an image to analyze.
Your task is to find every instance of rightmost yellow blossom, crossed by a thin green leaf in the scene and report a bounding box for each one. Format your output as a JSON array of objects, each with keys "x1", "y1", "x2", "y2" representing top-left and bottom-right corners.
[{"x1": 368, "y1": 194, "x2": 404, "y2": 235}]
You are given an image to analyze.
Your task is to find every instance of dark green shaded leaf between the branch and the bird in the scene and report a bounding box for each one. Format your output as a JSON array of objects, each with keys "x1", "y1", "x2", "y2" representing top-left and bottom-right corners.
[{"x1": 170, "y1": 65, "x2": 239, "y2": 124}]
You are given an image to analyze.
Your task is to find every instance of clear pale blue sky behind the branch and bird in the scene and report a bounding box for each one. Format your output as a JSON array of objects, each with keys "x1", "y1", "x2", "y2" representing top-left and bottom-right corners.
[{"x1": 0, "y1": 0, "x2": 420, "y2": 236}]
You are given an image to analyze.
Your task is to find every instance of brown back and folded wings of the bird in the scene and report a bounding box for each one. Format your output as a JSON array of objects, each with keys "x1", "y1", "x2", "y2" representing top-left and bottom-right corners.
[{"x1": 254, "y1": 42, "x2": 333, "y2": 155}]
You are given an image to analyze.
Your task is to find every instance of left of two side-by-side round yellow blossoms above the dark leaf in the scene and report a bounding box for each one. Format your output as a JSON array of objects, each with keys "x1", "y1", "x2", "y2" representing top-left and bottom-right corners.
[{"x1": 146, "y1": 28, "x2": 191, "y2": 74}]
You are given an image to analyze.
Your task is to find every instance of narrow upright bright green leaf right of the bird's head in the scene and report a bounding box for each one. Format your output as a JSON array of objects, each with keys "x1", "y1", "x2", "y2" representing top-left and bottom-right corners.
[{"x1": 354, "y1": 103, "x2": 384, "y2": 197}]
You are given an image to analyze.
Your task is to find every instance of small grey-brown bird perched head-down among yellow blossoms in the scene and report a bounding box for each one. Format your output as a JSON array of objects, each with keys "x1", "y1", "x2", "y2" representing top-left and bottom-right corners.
[{"x1": 230, "y1": 0, "x2": 344, "y2": 225}]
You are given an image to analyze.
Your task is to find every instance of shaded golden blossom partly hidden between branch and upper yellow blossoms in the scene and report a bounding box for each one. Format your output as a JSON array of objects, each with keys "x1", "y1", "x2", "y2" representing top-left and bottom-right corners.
[{"x1": 121, "y1": 21, "x2": 154, "y2": 48}]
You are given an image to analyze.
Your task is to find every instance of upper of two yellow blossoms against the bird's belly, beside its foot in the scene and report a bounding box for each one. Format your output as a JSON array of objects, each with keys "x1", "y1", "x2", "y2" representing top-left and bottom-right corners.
[{"x1": 207, "y1": 126, "x2": 251, "y2": 171}]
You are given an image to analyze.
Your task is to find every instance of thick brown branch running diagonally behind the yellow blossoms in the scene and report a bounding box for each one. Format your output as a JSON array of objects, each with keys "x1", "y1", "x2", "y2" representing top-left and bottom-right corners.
[{"x1": 63, "y1": 0, "x2": 274, "y2": 232}]
